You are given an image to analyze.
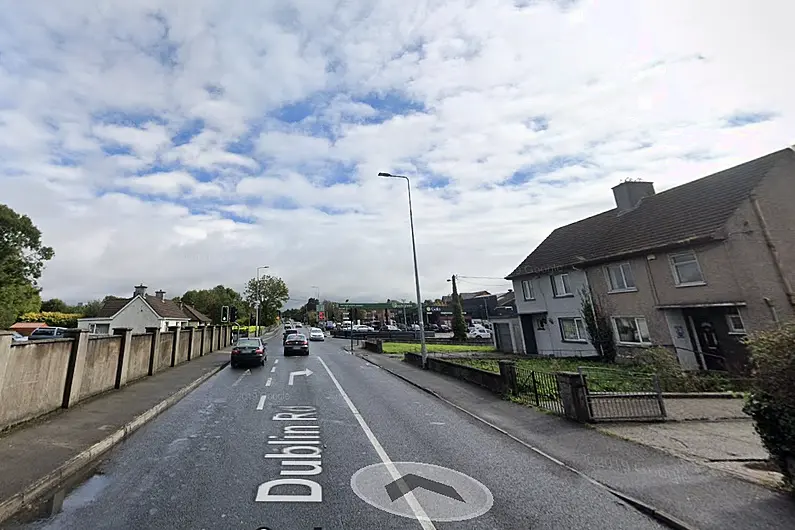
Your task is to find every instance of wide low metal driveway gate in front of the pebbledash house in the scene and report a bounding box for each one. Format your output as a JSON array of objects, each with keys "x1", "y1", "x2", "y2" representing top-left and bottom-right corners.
[{"x1": 577, "y1": 366, "x2": 666, "y2": 421}]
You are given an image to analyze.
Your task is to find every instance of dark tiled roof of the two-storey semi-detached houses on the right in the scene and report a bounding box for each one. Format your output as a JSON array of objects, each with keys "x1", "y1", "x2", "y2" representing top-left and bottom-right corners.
[{"x1": 506, "y1": 148, "x2": 795, "y2": 279}]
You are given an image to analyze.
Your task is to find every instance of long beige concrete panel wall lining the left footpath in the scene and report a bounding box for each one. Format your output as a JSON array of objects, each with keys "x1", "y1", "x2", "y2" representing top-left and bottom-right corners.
[{"x1": 0, "y1": 330, "x2": 233, "y2": 430}]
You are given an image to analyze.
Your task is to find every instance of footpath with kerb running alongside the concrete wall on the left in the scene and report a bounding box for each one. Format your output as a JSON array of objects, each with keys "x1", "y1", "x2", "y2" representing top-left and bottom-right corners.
[{"x1": 0, "y1": 332, "x2": 274, "y2": 524}]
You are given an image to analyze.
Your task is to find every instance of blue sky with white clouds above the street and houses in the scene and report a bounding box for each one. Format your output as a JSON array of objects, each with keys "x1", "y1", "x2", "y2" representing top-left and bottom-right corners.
[{"x1": 0, "y1": 0, "x2": 795, "y2": 301}]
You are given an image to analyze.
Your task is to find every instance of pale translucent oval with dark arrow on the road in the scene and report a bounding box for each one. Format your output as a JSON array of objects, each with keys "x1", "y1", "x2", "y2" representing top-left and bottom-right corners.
[{"x1": 351, "y1": 462, "x2": 494, "y2": 522}]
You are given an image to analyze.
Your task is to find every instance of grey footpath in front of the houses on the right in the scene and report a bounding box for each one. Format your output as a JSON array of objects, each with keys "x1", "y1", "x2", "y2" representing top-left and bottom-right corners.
[{"x1": 356, "y1": 351, "x2": 795, "y2": 530}]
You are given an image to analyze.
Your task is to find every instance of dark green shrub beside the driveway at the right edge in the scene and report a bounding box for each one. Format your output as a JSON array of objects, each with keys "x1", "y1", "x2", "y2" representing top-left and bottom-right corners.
[{"x1": 743, "y1": 322, "x2": 795, "y2": 486}]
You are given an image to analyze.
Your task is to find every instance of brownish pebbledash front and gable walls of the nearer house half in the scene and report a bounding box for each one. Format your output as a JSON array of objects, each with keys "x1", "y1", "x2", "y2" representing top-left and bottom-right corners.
[{"x1": 587, "y1": 153, "x2": 795, "y2": 360}]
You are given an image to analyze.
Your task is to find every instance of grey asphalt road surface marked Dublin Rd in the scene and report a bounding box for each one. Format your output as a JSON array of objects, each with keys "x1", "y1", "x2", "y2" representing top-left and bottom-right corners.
[{"x1": 6, "y1": 334, "x2": 661, "y2": 530}]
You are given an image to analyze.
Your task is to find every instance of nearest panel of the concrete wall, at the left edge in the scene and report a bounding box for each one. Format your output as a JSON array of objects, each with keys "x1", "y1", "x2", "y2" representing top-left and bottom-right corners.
[{"x1": 0, "y1": 335, "x2": 72, "y2": 429}]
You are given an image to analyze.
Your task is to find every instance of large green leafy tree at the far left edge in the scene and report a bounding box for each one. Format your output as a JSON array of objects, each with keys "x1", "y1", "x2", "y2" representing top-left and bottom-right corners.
[{"x1": 0, "y1": 204, "x2": 54, "y2": 329}]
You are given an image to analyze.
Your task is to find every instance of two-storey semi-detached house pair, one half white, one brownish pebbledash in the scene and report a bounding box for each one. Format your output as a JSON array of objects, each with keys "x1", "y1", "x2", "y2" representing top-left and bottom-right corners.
[{"x1": 507, "y1": 148, "x2": 795, "y2": 371}]
